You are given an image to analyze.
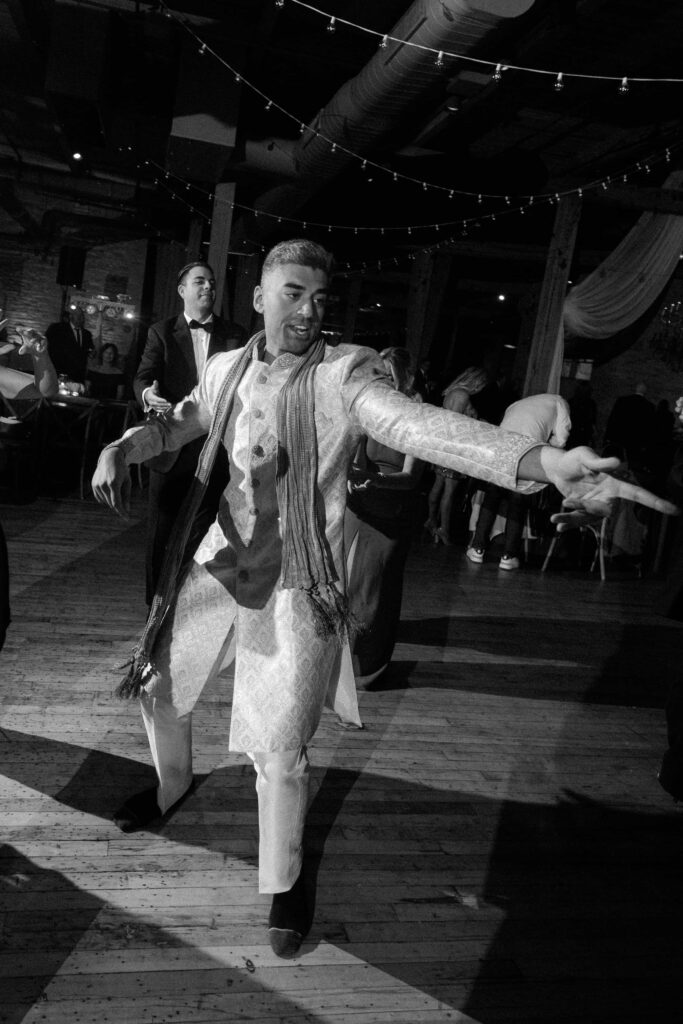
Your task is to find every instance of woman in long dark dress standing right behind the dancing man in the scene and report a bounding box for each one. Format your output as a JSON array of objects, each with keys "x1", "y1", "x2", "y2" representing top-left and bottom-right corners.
[{"x1": 344, "y1": 347, "x2": 424, "y2": 685}]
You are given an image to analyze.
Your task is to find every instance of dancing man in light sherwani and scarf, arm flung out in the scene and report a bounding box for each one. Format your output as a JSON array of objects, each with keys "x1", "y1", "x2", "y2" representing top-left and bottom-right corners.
[{"x1": 93, "y1": 240, "x2": 675, "y2": 956}]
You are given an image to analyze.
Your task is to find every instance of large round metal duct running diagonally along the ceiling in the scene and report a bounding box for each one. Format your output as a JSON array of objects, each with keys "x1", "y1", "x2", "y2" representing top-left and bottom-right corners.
[{"x1": 242, "y1": 0, "x2": 533, "y2": 230}]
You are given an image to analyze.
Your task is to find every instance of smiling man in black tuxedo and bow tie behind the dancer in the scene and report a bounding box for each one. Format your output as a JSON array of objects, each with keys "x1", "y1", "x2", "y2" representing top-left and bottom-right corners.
[{"x1": 133, "y1": 260, "x2": 245, "y2": 604}]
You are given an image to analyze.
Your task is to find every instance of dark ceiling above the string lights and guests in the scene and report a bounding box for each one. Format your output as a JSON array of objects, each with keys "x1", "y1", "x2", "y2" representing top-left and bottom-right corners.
[{"x1": 0, "y1": 0, "x2": 683, "y2": 278}]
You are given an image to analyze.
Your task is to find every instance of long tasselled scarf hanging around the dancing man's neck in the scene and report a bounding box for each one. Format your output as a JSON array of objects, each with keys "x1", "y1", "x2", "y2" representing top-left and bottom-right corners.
[{"x1": 117, "y1": 331, "x2": 357, "y2": 697}]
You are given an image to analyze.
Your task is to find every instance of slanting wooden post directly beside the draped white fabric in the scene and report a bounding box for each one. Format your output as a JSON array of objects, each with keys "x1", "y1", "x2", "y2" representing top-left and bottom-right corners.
[{"x1": 524, "y1": 196, "x2": 581, "y2": 395}]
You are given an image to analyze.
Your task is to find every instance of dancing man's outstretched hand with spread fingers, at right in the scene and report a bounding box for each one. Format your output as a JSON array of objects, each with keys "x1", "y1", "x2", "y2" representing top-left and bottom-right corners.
[{"x1": 541, "y1": 446, "x2": 679, "y2": 531}]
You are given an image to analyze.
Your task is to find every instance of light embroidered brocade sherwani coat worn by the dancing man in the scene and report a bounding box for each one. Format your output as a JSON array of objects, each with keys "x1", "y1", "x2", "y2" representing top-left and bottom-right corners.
[{"x1": 118, "y1": 345, "x2": 538, "y2": 751}]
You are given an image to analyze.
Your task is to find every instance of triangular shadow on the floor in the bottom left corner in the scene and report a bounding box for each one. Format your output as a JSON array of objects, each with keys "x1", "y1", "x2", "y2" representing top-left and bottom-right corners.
[{"x1": 0, "y1": 846, "x2": 339, "y2": 1024}]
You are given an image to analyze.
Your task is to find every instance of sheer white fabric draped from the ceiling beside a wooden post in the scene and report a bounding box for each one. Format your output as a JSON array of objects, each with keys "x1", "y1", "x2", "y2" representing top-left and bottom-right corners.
[{"x1": 548, "y1": 171, "x2": 683, "y2": 392}]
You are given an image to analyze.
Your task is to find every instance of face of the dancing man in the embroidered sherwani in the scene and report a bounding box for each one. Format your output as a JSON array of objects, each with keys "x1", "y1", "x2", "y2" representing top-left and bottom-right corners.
[{"x1": 254, "y1": 263, "x2": 328, "y2": 356}]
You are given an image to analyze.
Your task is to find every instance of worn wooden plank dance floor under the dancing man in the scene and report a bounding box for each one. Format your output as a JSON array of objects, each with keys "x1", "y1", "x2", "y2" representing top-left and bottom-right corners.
[{"x1": 0, "y1": 491, "x2": 683, "y2": 1024}]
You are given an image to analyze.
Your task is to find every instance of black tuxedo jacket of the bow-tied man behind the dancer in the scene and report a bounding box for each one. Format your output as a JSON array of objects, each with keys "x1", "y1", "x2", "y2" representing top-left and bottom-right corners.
[{"x1": 133, "y1": 313, "x2": 239, "y2": 474}]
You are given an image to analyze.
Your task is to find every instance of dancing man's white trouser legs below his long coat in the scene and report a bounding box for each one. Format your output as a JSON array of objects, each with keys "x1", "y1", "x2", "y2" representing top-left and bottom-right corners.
[{"x1": 140, "y1": 695, "x2": 308, "y2": 893}]
